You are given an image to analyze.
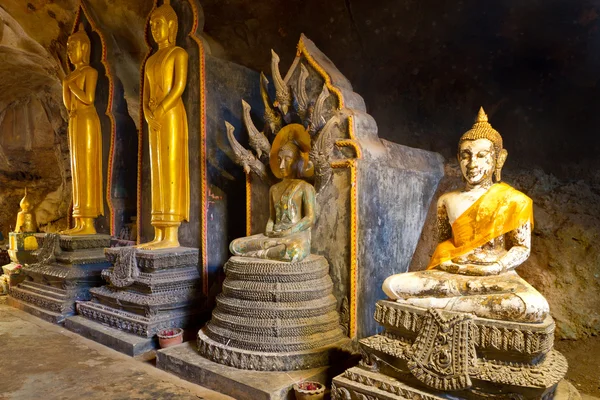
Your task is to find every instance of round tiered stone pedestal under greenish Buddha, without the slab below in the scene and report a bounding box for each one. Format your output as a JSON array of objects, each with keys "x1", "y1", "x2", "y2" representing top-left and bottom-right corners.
[{"x1": 198, "y1": 255, "x2": 348, "y2": 371}]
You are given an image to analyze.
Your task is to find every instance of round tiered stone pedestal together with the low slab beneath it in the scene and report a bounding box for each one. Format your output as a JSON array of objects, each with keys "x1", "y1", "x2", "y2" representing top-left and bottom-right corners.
[{"x1": 157, "y1": 255, "x2": 350, "y2": 400}]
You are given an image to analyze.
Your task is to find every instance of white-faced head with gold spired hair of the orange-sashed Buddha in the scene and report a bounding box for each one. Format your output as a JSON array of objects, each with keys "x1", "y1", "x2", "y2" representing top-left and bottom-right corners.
[{"x1": 458, "y1": 107, "x2": 508, "y2": 185}]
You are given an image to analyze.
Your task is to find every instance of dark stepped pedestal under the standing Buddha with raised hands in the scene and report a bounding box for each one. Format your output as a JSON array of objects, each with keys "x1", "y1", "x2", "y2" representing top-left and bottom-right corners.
[{"x1": 9, "y1": 233, "x2": 110, "y2": 323}]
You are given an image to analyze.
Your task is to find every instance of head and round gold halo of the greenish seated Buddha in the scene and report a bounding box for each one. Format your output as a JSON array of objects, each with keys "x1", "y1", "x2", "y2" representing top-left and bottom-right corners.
[{"x1": 269, "y1": 124, "x2": 314, "y2": 179}]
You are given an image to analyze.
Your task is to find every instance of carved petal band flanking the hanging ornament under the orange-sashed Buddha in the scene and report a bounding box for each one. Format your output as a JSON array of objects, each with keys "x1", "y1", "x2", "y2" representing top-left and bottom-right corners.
[{"x1": 375, "y1": 303, "x2": 554, "y2": 354}]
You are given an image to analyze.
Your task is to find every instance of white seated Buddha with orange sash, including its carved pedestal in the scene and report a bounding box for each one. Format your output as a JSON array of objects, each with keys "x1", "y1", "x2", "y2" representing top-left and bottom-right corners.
[{"x1": 332, "y1": 109, "x2": 567, "y2": 400}]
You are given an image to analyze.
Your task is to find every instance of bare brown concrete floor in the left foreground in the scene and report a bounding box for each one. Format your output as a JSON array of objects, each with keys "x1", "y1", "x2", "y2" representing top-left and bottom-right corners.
[{"x1": 0, "y1": 296, "x2": 231, "y2": 400}]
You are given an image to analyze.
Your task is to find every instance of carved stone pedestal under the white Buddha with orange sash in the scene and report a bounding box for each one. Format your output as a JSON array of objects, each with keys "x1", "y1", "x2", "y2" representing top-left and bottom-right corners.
[{"x1": 332, "y1": 300, "x2": 567, "y2": 400}]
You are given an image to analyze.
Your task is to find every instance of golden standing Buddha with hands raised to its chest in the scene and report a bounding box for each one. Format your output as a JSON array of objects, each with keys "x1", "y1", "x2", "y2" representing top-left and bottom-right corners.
[{"x1": 61, "y1": 24, "x2": 104, "y2": 235}]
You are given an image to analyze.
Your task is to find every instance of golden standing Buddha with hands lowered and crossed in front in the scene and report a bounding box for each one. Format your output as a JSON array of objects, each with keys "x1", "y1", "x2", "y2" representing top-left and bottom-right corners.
[{"x1": 138, "y1": 0, "x2": 190, "y2": 250}]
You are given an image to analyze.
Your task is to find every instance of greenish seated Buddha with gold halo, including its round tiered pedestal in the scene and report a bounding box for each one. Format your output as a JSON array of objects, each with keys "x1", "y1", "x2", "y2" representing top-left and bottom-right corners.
[{"x1": 198, "y1": 124, "x2": 348, "y2": 371}]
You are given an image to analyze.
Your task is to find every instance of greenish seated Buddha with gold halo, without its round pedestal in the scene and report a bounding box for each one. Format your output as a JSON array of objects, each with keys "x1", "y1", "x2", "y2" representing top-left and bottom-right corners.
[{"x1": 229, "y1": 124, "x2": 315, "y2": 262}]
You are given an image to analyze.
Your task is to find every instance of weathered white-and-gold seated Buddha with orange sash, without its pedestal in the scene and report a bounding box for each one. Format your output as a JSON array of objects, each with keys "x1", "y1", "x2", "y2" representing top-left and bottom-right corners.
[{"x1": 383, "y1": 108, "x2": 549, "y2": 322}]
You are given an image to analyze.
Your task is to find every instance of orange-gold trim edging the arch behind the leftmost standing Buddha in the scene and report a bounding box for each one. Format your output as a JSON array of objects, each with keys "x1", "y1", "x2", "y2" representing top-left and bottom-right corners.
[{"x1": 72, "y1": 0, "x2": 116, "y2": 236}]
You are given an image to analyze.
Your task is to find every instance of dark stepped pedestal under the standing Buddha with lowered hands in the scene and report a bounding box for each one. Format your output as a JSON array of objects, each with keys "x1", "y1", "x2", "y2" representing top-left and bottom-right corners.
[{"x1": 65, "y1": 247, "x2": 202, "y2": 356}]
